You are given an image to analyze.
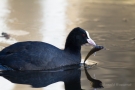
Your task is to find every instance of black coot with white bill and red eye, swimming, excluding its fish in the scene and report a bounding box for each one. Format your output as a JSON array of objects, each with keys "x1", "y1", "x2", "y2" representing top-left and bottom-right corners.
[{"x1": 0, "y1": 27, "x2": 96, "y2": 70}]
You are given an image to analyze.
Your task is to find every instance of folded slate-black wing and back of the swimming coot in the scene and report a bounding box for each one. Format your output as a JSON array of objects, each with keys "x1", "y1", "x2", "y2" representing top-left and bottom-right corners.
[{"x1": 0, "y1": 42, "x2": 60, "y2": 69}]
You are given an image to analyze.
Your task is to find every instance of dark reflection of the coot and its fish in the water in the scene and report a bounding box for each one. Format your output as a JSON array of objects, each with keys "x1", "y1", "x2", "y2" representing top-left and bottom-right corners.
[{"x1": 0, "y1": 66, "x2": 102, "y2": 90}]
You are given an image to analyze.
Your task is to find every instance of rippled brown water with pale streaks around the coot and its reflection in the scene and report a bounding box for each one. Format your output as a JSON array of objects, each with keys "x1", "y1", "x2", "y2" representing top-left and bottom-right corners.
[{"x1": 0, "y1": 0, "x2": 135, "y2": 90}]
